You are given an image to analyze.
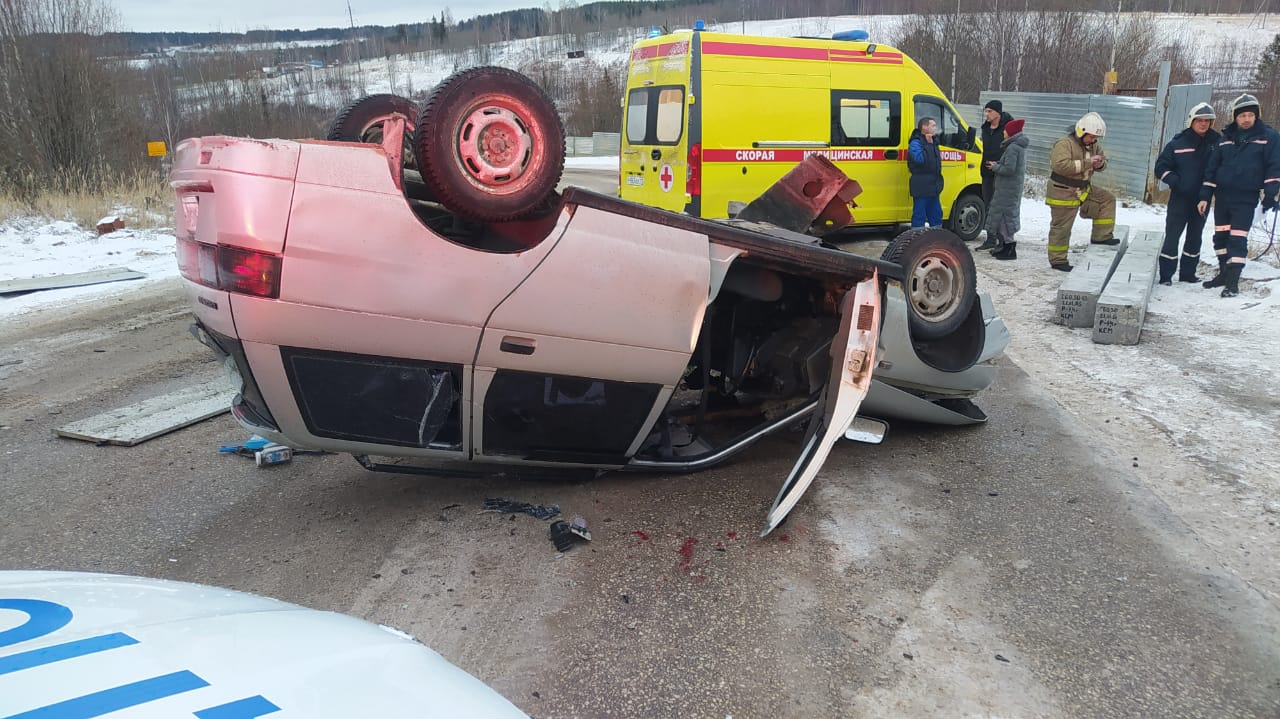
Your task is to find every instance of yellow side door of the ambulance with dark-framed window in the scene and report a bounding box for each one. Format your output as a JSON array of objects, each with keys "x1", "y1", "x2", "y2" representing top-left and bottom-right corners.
[{"x1": 827, "y1": 90, "x2": 911, "y2": 225}]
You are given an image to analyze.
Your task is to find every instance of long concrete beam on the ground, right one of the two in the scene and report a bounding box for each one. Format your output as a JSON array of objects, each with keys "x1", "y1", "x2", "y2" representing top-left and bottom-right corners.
[{"x1": 1093, "y1": 230, "x2": 1165, "y2": 344}]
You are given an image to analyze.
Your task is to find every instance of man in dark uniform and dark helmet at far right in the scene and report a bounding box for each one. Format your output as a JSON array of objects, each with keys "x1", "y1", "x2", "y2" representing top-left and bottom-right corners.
[{"x1": 1197, "y1": 95, "x2": 1280, "y2": 297}]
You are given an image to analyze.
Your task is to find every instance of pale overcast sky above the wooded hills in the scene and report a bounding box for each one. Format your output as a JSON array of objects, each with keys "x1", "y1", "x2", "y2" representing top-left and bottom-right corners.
[{"x1": 115, "y1": 0, "x2": 576, "y2": 32}]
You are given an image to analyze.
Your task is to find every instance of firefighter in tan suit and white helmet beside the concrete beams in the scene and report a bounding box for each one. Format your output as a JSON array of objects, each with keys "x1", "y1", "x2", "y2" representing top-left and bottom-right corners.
[{"x1": 1044, "y1": 113, "x2": 1120, "y2": 271}]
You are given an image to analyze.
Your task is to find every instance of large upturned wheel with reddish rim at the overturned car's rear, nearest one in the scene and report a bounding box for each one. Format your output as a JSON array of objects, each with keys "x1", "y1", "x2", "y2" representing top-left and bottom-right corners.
[{"x1": 413, "y1": 68, "x2": 564, "y2": 223}]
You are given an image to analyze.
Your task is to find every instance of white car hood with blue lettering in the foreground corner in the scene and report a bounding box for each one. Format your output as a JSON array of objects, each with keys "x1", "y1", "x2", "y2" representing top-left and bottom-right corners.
[{"x1": 0, "y1": 572, "x2": 526, "y2": 719}]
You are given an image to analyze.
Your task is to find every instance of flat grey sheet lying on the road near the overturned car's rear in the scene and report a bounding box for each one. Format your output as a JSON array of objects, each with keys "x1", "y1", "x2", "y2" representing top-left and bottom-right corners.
[{"x1": 54, "y1": 377, "x2": 236, "y2": 446}]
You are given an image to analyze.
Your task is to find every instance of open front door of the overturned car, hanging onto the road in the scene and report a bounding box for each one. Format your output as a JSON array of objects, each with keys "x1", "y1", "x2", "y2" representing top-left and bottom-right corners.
[{"x1": 760, "y1": 273, "x2": 881, "y2": 537}]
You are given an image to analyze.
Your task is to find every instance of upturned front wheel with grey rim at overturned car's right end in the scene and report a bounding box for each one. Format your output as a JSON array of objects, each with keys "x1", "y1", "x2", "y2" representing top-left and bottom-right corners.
[{"x1": 881, "y1": 228, "x2": 978, "y2": 340}]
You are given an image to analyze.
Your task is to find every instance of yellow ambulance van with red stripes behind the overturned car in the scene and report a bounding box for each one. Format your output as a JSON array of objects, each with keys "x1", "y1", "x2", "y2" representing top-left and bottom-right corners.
[{"x1": 618, "y1": 22, "x2": 986, "y2": 239}]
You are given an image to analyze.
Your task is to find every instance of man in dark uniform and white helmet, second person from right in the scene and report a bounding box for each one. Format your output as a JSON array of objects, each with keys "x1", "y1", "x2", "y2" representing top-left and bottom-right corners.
[{"x1": 1156, "y1": 102, "x2": 1221, "y2": 285}]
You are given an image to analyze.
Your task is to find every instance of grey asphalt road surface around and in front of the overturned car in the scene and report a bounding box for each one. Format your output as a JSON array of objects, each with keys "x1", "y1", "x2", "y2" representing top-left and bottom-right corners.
[{"x1": 0, "y1": 182, "x2": 1280, "y2": 719}]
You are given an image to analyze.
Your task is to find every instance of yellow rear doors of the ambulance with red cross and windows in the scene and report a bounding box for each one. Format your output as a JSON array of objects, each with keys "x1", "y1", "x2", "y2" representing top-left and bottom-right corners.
[{"x1": 618, "y1": 84, "x2": 689, "y2": 212}]
